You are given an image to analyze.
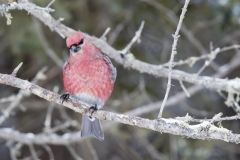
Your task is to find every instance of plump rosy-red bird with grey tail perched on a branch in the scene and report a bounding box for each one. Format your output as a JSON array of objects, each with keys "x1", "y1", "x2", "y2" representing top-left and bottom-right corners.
[{"x1": 61, "y1": 32, "x2": 117, "y2": 140}]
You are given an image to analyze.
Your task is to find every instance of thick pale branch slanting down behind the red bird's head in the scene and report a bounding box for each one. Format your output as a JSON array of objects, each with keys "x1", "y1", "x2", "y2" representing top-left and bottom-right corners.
[{"x1": 0, "y1": 0, "x2": 240, "y2": 93}]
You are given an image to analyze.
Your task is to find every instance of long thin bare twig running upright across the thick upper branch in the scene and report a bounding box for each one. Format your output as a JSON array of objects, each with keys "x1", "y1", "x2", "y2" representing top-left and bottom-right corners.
[{"x1": 158, "y1": 0, "x2": 190, "y2": 118}]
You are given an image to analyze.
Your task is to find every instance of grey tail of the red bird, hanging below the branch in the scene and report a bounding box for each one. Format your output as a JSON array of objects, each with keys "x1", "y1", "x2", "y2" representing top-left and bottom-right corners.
[{"x1": 81, "y1": 115, "x2": 104, "y2": 141}]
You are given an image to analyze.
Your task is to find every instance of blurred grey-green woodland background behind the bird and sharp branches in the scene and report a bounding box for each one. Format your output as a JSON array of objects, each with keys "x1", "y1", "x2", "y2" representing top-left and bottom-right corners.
[{"x1": 0, "y1": 0, "x2": 240, "y2": 160}]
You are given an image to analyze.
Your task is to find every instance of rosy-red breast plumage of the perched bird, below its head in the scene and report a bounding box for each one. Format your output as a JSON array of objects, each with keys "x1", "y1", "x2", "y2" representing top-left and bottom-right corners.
[{"x1": 63, "y1": 33, "x2": 116, "y2": 102}]
